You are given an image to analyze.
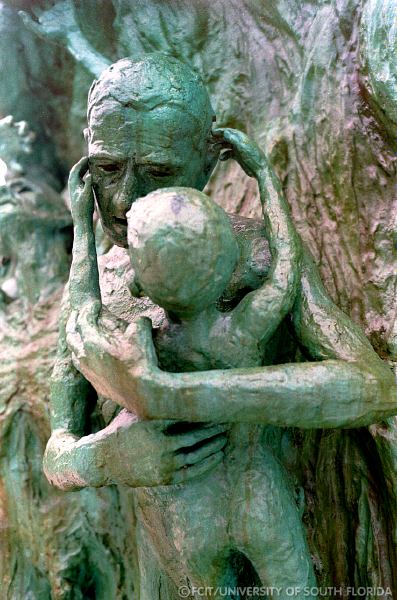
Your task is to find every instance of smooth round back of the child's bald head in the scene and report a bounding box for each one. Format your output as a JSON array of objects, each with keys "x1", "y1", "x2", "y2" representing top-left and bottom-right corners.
[{"x1": 128, "y1": 187, "x2": 238, "y2": 316}]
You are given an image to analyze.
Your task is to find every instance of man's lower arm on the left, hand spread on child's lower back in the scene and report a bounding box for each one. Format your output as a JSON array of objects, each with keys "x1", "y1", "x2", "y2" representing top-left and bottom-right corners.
[{"x1": 43, "y1": 296, "x2": 227, "y2": 491}]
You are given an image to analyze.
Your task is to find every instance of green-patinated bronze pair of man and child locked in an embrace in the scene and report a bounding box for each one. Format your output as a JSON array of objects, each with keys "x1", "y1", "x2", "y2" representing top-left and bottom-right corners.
[{"x1": 44, "y1": 53, "x2": 397, "y2": 600}]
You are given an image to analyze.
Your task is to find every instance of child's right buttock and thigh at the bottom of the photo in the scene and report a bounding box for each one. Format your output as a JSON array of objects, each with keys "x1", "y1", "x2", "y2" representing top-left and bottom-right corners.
[{"x1": 232, "y1": 448, "x2": 316, "y2": 600}]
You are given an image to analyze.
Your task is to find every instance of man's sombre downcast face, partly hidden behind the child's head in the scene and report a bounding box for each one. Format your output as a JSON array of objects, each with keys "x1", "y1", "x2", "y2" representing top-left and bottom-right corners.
[{"x1": 88, "y1": 101, "x2": 216, "y2": 247}]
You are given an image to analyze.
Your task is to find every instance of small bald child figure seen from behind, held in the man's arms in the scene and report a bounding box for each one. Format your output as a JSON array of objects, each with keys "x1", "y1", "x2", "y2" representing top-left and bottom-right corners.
[{"x1": 70, "y1": 159, "x2": 315, "y2": 600}]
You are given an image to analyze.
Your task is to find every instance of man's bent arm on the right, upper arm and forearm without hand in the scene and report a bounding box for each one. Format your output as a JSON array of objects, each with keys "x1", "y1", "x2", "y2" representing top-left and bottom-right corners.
[{"x1": 131, "y1": 246, "x2": 397, "y2": 428}]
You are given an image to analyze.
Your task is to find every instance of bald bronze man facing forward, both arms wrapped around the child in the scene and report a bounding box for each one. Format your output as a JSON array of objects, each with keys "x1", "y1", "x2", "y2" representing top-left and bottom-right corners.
[{"x1": 46, "y1": 55, "x2": 397, "y2": 596}]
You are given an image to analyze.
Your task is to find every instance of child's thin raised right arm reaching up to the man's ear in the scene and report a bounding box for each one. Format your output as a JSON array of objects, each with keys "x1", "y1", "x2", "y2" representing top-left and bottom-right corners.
[{"x1": 213, "y1": 129, "x2": 301, "y2": 342}]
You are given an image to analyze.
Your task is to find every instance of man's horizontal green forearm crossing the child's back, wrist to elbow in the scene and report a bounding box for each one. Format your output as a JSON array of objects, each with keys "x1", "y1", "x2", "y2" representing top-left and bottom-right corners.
[{"x1": 137, "y1": 360, "x2": 397, "y2": 429}]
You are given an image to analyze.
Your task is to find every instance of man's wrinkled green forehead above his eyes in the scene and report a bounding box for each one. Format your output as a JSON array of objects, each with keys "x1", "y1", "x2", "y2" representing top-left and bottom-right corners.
[{"x1": 88, "y1": 101, "x2": 203, "y2": 158}]
